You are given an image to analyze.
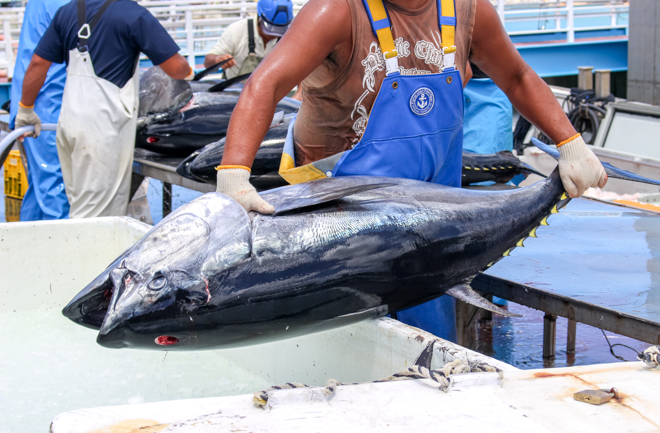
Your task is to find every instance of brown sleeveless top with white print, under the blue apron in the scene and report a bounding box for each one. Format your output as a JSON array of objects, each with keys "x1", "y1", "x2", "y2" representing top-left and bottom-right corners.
[{"x1": 294, "y1": 0, "x2": 476, "y2": 166}]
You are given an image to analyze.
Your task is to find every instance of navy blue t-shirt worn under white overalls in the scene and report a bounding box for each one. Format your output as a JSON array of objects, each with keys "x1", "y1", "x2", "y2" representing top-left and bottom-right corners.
[{"x1": 34, "y1": 0, "x2": 179, "y2": 87}]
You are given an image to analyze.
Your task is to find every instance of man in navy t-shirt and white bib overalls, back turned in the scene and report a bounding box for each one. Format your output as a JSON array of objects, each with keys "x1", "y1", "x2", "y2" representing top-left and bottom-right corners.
[{"x1": 16, "y1": 0, "x2": 194, "y2": 218}]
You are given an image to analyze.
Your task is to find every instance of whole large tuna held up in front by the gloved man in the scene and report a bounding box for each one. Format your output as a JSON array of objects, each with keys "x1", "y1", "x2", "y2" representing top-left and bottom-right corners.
[{"x1": 63, "y1": 140, "x2": 660, "y2": 350}]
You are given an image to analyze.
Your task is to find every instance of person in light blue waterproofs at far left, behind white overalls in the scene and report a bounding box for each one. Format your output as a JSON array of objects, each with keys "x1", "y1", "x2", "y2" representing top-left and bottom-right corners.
[{"x1": 9, "y1": 0, "x2": 69, "y2": 221}]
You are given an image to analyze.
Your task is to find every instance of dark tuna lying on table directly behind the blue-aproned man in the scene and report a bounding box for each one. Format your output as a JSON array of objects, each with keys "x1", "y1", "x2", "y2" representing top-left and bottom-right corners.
[{"x1": 176, "y1": 113, "x2": 543, "y2": 191}]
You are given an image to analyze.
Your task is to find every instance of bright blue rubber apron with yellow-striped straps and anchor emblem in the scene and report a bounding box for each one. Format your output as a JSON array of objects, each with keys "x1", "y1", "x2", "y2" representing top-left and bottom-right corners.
[{"x1": 280, "y1": 0, "x2": 463, "y2": 341}]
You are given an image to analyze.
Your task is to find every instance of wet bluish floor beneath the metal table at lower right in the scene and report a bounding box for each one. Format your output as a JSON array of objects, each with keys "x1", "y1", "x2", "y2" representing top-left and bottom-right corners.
[{"x1": 468, "y1": 302, "x2": 651, "y2": 370}]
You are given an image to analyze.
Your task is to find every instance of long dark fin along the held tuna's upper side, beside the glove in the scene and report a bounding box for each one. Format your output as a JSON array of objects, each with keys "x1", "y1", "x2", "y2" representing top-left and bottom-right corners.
[{"x1": 260, "y1": 176, "x2": 394, "y2": 215}]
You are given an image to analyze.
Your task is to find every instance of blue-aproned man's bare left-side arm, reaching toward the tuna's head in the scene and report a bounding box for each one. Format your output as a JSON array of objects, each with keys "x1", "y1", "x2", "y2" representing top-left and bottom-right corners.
[{"x1": 222, "y1": 0, "x2": 352, "y2": 167}]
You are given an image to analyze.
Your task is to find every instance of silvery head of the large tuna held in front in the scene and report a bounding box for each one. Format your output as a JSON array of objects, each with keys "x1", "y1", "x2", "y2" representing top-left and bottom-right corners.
[{"x1": 75, "y1": 193, "x2": 251, "y2": 349}]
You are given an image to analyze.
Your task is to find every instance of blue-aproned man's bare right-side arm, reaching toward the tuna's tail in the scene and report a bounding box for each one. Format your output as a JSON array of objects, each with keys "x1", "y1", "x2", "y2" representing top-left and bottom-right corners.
[{"x1": 470, "y1": 0, "x2": 576, "y2": 143}]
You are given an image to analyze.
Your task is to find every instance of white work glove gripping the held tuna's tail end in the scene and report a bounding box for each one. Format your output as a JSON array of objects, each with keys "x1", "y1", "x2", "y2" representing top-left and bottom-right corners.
[{"x1": 557, "y1": 135, "x2": 607, "y2": 198}]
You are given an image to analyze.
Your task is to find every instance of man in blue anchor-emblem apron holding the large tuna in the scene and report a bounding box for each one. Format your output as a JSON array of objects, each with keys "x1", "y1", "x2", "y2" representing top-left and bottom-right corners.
[{"x1": 217, "y1": 0, "x2": 607, "y2": 339}]
